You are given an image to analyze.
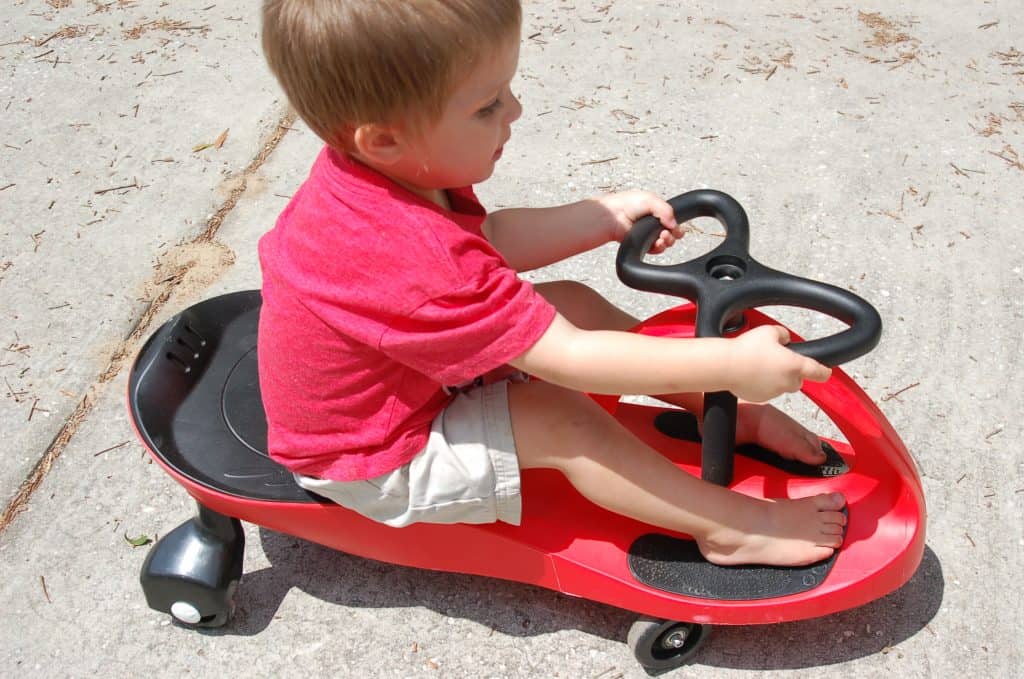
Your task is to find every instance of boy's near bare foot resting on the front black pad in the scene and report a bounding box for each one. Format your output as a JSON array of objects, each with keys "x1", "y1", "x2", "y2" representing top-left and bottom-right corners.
[{"x1": 696, "y1": 493, "x2": 846, "y2": 566}]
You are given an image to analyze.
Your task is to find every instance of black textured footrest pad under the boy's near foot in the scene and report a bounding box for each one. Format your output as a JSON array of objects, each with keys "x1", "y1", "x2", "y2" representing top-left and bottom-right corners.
[{"x1": 629, "y1": 533, "x2": 839, "y2": 601}]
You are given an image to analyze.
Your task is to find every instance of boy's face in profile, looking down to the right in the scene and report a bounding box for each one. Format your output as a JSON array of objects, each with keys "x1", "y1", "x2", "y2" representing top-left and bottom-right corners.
[{"x1": 387, "y1": 36, "x2": 522, "y2": 200}]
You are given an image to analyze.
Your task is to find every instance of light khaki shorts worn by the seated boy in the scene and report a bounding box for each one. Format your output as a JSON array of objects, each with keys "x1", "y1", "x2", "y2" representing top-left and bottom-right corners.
[{"x1": 295, "y1": 381, "x2": 522, "y2": 527}]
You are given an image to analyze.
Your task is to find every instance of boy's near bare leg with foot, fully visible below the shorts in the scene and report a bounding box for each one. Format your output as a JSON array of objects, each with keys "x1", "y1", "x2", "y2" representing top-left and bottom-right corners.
[{"x1": 509, "y1": 382, "x2": 846, "y2": 565}]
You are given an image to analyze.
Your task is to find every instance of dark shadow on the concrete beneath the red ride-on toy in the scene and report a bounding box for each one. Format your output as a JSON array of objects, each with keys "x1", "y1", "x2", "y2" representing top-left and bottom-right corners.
[{"x1": 192, "y1": 528, "x2": 944, "y2": 670}]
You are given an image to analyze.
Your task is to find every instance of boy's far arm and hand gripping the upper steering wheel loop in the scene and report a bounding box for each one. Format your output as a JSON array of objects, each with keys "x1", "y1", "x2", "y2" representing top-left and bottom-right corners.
[{"x1": 482, "y1": 190, "x2": 682, "y2": 271}]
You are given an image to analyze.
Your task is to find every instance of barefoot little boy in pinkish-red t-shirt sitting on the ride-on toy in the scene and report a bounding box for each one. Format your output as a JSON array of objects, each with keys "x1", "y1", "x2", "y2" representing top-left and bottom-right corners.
[{"x1": 259, "y1": 0, "x2": 845, "y2": 565}]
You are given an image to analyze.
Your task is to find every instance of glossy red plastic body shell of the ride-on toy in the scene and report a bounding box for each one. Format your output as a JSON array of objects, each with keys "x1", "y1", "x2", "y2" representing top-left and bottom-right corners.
[{"x1": 136, "y1": 304, "x2": 926, "y2": 625}]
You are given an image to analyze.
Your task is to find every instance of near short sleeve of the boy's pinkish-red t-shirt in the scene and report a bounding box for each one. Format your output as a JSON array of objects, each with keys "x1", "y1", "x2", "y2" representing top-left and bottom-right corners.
[{"x1": 380, "y1": 266, "x2": 555, "y2": 384}]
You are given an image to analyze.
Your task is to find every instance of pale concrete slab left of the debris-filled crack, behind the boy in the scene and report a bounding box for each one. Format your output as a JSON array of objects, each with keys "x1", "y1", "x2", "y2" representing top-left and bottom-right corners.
[{"x1": 0, "y1": 0, "x2": 285, "y2": 505}]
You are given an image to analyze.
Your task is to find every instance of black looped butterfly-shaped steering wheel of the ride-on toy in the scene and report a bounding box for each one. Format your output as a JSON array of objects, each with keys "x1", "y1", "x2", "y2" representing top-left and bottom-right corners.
[{"x1": 615, "y1": 189, "x2": 882, "y2": 367}]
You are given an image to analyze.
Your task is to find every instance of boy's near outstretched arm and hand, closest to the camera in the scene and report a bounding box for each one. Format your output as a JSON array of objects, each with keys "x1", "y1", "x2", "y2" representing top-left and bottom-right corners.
[{"x1": 510, "y1": 315, "x2": 831, "y2": 401}]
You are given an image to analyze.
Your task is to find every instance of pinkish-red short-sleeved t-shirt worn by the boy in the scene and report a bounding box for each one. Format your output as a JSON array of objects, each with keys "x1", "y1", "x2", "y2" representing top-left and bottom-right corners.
[{"x1": 258, "y1": 148, "x2": 555, "y2": 480}]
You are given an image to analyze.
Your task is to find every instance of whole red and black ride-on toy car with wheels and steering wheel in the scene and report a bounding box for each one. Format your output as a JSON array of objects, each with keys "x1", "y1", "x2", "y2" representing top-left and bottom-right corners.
[{"x1": 128, "y1": 190, "x2": 925, "y2": 672}]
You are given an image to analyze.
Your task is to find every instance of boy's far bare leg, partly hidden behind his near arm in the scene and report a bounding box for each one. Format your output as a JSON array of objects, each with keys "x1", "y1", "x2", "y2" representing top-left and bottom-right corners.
[{"x1": 536, "y1": 281, "x2": 825, "y2": 464}]
